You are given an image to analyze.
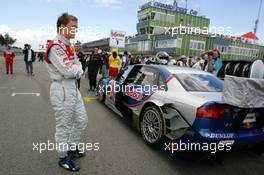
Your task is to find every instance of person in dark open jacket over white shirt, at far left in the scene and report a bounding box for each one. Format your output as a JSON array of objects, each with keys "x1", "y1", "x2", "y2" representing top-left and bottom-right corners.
[{"x1": 23, "y1": 44, "x2": 36, "y2": 76}]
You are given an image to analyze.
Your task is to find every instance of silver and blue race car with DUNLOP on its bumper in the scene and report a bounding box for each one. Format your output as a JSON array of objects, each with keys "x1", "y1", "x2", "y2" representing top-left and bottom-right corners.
[{"x1": 98, "y1": 65, "x2": 264, "y2": 150}]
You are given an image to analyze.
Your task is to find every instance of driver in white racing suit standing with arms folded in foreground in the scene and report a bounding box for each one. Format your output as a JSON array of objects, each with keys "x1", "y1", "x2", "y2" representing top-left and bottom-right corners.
[{"x1": 45, "y1": 13, "x2": 88, "y2": 172}]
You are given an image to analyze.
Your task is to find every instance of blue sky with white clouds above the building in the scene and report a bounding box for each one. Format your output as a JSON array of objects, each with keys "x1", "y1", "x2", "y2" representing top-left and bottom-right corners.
[{"x1": 0, "y1": 0, "x2": 264, "y2": 49}]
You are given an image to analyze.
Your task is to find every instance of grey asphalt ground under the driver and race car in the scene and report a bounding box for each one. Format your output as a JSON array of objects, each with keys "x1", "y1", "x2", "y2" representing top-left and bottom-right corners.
[{"x1": 0, "y1": 57, "x2": 264, "y2": 175}]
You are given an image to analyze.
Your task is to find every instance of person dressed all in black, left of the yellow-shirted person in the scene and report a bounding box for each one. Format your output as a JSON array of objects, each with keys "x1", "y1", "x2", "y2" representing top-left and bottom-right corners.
[{"x1": 88, "y1": 48, "x2": 102, "y2": 91}]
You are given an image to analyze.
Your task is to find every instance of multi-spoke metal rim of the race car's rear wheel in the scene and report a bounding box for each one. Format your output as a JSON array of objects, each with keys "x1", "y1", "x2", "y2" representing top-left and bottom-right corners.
[{"x1": 142, "y1": 111, "x2": 160, "y2": 143}]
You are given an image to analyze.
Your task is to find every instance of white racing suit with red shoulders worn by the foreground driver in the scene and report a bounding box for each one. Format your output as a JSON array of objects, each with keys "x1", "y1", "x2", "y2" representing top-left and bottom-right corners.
[{"x1": 45, "y1": 35, "x2": 88, "y2": 158}]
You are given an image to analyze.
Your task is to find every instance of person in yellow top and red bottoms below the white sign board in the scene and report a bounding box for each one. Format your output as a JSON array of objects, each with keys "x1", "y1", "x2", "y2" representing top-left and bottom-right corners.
[{"x1": 109, "y1": 48, "x2": 120, "y2": 78}]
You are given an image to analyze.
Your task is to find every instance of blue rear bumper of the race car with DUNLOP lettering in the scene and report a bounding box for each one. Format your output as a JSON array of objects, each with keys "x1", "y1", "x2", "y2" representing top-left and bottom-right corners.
[{"x1": 188, "y1": 118, "x2": 264, "y2": 146}]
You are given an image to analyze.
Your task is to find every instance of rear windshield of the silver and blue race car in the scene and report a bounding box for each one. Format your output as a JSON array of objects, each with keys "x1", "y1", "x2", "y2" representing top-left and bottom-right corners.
[{"x1": 175, "y1": 74, "x2": 224, "y2": 92}]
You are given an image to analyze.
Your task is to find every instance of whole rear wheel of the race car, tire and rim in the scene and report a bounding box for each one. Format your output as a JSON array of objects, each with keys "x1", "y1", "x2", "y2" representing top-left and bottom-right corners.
[{"x1": 140, "y1": 105, "x2": 165, "y2": 146}]
